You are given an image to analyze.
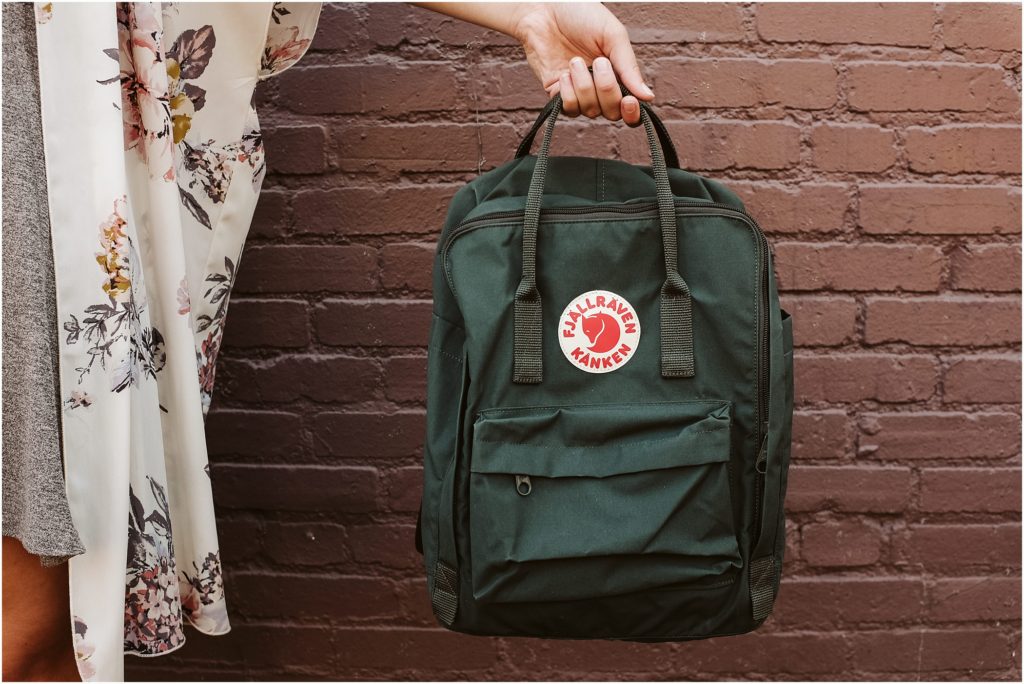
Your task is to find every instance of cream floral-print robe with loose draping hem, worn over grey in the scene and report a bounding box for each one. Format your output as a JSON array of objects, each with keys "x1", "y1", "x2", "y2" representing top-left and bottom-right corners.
[{"x1": 36, "y1": 2, "x2": 319, "y2": 681}]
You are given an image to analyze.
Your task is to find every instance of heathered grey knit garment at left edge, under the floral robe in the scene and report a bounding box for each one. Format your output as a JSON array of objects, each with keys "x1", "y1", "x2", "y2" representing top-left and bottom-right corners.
[{"x1": 3, "y1": 2, "x2": 84, "y2": 565}]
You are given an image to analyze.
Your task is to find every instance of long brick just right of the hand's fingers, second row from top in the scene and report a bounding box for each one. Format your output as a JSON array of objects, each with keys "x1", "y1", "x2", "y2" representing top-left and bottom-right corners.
[{"x1": 654, "y1": 57, "x2": 838, "y2": 110}]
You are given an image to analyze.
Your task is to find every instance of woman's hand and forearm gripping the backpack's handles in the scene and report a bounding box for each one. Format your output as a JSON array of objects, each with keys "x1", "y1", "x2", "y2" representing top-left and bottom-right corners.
[{"x1": 412, "y1": 2, "x2": 654, "y2": 126}]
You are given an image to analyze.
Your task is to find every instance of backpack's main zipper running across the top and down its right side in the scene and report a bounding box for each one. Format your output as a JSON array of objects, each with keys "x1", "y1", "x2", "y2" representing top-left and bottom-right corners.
[{"x1": 441, "y1": 200, "x2": 770, "y2": 549}]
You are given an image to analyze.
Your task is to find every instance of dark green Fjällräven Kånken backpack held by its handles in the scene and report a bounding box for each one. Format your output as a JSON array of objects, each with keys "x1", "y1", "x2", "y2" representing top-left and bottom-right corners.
[{"x1": 417, "y1": 96, "x2": 793, "y2": 641}]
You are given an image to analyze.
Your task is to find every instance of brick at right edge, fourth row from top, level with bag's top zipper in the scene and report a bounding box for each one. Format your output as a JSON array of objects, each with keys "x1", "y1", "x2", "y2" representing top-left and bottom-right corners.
[{"x1": 860, "y1": 183, "x2": 1021, "y2": 234}]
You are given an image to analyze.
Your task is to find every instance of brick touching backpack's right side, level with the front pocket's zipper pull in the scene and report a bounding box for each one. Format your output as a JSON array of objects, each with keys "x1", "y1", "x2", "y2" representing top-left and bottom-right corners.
[{"x1": 785, "y1": 466, "x2": 910, "y2": 513}]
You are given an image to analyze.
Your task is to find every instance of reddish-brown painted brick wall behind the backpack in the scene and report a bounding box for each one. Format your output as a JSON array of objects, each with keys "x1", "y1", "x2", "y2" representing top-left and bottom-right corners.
[{"x1": 129, "y1": 3, "x2": 1021, "y2": 680}]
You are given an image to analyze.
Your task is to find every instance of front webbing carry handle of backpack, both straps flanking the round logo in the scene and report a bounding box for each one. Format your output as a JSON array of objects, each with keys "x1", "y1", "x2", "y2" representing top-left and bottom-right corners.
[{"x1": 512, "y1": 95, "x2": 694, "y2": 384}]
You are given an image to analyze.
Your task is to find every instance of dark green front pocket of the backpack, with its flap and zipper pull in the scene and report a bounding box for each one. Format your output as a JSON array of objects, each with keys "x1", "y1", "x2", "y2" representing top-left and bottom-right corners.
[{"x1": 469, "y1": 401, "x2": 742, "y2": 602}]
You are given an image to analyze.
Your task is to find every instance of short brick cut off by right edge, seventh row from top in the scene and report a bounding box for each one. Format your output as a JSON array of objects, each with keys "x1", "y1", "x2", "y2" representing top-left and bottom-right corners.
[{"x1": 942, "y1": 354, "x2": 1021, "y2": 403}]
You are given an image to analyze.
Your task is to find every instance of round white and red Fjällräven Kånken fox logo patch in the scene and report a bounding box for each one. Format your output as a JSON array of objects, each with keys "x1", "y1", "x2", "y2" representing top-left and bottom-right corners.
[{"x1": 558, "y1": 290, "x2": 640, "y2": 373}]
